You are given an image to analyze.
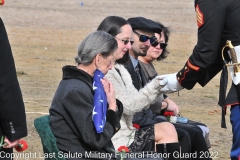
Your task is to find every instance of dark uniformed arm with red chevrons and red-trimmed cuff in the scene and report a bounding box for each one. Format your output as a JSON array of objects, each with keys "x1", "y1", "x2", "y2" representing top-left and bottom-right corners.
[{"x1": 177, "y1": 1, "x2": 226, "y2": 89}]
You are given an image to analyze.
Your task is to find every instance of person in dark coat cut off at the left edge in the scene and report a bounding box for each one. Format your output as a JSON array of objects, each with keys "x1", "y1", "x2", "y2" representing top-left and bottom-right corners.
[{"x1": 0, "y1": 18, "x2": 27, "y2": 160}]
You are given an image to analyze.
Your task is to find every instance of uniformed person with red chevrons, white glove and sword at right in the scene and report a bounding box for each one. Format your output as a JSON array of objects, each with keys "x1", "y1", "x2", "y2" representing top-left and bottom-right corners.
[{"x1": 160, "y1": 0, "x2": 240, "y2": 160}]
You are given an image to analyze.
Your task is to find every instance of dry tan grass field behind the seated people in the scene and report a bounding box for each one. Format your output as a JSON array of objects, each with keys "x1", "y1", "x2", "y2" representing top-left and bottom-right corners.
[{"x1": 0, "y1": 0, "x2": 232, "y2": 160}]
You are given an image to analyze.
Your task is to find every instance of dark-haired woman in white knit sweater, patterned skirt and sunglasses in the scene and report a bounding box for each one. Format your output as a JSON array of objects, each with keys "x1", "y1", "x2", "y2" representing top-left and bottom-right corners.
[{"x1": 97, "y1": 16, "x2": 180, "y2": 160}]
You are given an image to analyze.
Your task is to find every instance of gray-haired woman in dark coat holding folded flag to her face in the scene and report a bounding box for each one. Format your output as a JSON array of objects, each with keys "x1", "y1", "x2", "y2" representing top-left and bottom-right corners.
[{"x1": 50, "y1": 31, "x2": 122, "y2": 159}]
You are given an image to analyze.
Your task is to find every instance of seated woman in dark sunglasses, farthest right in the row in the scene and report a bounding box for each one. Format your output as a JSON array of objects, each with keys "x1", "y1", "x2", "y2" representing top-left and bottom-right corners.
[{"x1": 138, "y1": 22, "x2": 210, "y2": 158}]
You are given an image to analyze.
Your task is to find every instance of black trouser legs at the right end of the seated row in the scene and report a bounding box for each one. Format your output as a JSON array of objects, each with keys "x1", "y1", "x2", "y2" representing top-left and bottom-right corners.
[{"x1": 174, "y1": 123, "x2": 212, "y2": 160}]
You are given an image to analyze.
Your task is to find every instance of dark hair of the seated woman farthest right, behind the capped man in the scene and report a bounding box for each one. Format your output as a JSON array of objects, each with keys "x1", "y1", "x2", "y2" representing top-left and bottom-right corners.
[{"x1": 156, "y1": 22, "x2": 170, "y2": 61}]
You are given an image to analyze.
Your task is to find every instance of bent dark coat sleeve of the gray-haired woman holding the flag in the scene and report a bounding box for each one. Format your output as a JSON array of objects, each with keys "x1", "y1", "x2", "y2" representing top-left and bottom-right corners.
[{"x1": 63, "y1": 89, "x2": 120, "y2": 150}]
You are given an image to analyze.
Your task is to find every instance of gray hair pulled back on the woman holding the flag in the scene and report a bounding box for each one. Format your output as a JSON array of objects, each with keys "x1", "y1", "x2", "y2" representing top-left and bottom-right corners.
[{"x1": 75, "y1": 31, "x2": 118, "y2": 65}]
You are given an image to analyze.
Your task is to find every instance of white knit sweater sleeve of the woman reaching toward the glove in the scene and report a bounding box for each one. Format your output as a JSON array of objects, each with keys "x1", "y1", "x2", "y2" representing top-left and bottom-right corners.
[{"x1": 106, "y1": 65, "x2": 161, "y2": 115}]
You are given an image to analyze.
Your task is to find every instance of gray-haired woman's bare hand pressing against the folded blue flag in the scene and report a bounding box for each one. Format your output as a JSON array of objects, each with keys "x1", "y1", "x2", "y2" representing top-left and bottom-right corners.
[{"x1": 101, "y1": 77, "x2": 117, "y2": 111}]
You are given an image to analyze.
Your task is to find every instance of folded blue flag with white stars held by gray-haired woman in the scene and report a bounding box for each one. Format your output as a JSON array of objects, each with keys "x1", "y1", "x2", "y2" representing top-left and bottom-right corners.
[{"x1": 92, "y1": 69, "x2": 107, "y2": 133}]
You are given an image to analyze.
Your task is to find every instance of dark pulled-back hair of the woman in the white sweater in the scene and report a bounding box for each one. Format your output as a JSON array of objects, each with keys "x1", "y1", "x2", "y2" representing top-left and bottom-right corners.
[{"x1": 97, "y1": 16, "x2": 129, "y2": 64}]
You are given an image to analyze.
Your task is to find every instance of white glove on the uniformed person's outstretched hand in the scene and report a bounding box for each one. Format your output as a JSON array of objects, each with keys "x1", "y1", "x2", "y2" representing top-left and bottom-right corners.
[{"x1": 157, "y1": 73, "x2": 183, "y2": 93}]
